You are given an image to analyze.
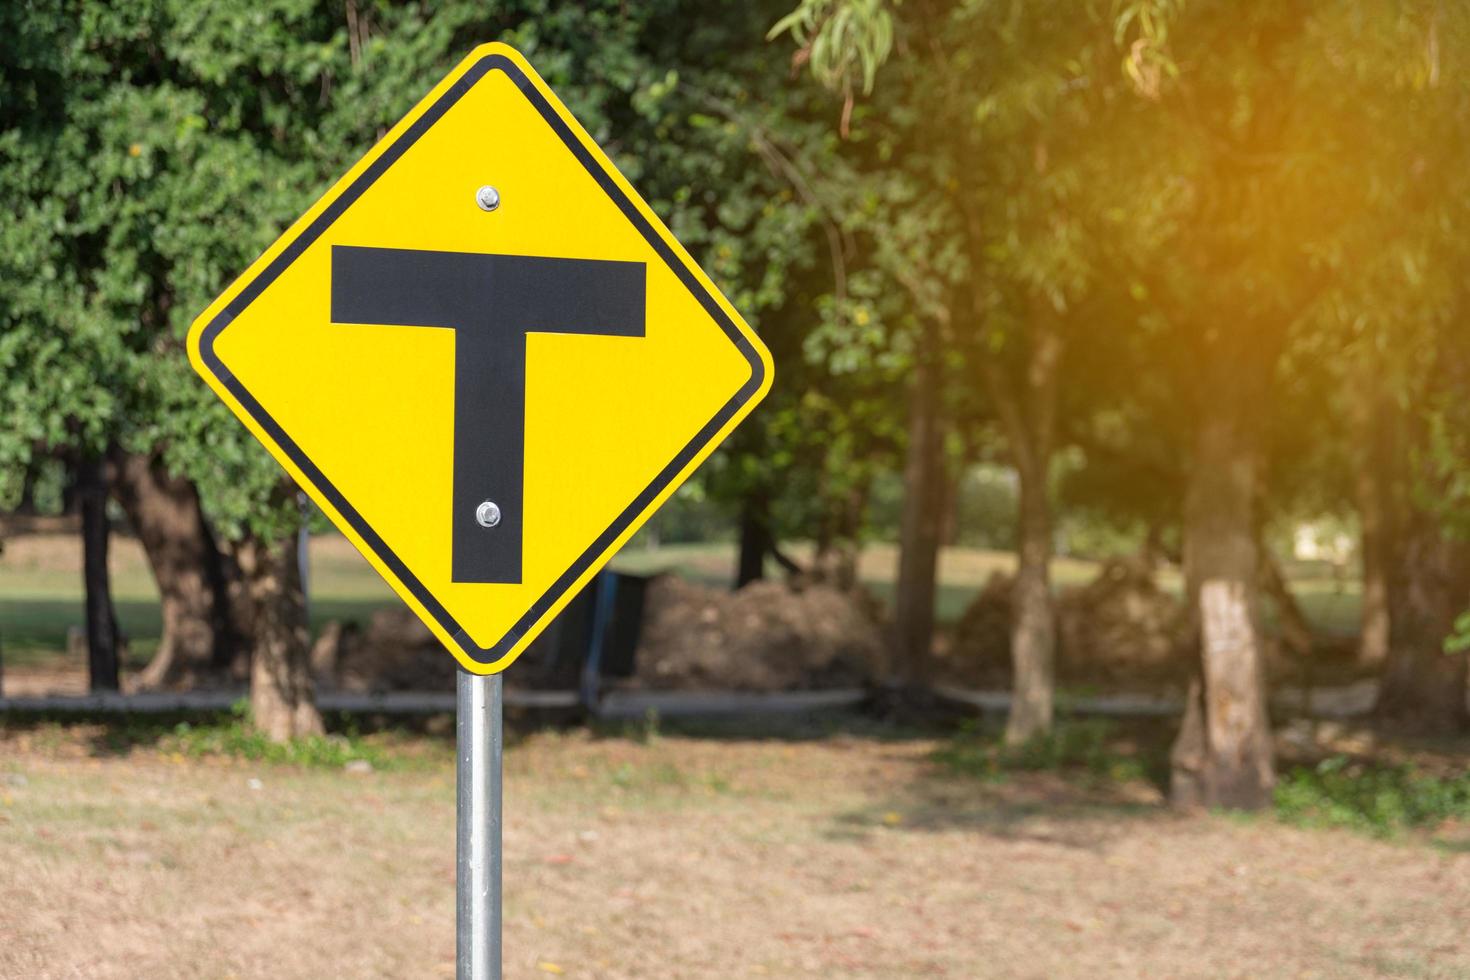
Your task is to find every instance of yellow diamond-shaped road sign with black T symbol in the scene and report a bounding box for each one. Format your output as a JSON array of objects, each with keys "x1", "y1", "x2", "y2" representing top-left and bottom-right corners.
[{"x1": 188, "y1": 44, "x2": 772, "y2": 673}]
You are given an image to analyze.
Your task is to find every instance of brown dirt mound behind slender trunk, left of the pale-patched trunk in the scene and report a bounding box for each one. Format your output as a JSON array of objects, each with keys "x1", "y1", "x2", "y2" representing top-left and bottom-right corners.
[{"x1": 941, "y1": 560, "x2": 1189, "y2": 686}]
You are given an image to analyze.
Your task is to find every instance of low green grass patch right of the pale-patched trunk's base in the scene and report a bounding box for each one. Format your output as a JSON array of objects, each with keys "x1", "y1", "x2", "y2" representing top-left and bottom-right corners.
[{"x1": 1276, "y1": 755, "x2": 1470, "y2": 837}]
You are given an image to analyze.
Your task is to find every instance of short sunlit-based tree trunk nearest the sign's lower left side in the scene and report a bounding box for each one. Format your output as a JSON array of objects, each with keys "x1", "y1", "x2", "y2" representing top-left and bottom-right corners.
[{"x1": 235, "y1": 536, "x2": 323, "y2": 742}]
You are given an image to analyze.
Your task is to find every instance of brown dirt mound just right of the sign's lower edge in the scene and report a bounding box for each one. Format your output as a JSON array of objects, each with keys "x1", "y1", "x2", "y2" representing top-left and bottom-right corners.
[{"x1": 631, "y1": 576, "x2": 882, "y2": 691}]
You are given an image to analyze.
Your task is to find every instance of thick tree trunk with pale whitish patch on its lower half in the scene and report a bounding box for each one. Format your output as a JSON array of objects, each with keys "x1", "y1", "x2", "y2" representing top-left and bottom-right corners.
[{"x1": 1172, "y1": 405, "x2": 1276, "y2": 810}]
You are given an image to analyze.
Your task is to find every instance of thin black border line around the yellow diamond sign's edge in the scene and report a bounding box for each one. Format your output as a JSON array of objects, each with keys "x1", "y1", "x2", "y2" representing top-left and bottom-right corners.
[{"x1": 198, "y1": 54, "x2": 766, "y2": 666}]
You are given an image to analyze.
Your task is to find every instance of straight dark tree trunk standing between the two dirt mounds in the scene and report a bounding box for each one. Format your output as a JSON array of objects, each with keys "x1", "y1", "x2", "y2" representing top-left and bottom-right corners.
[{"x1": 892, "y1": 320, "x2": 945, "y2": 688}]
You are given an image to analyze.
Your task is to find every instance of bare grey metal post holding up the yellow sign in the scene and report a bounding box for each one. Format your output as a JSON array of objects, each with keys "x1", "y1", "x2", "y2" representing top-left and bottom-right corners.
[{"x1": 454, "y1": 670, "x2": 504, "y2": 980}]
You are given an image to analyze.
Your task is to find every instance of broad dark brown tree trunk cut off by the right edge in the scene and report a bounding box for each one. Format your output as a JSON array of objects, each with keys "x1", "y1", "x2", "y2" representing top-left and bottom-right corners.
[{"x1": 1376, "y1": 513, "x2": 1470, "y2": 735}]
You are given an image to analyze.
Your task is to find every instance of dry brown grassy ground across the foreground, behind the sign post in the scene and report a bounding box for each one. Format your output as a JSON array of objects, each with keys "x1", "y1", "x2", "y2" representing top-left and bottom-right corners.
[{"x1": 0, "y1": 724, "x2": 1470, "y2": 980}]
